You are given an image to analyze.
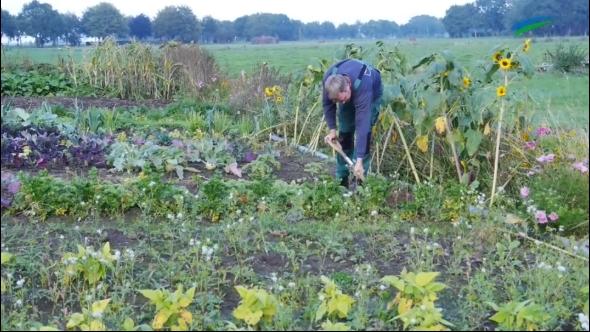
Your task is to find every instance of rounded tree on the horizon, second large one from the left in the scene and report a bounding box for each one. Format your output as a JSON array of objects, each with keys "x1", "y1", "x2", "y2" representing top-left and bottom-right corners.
[{"x1": 82, "y1": 2, "x2": 129, "y2": 40}]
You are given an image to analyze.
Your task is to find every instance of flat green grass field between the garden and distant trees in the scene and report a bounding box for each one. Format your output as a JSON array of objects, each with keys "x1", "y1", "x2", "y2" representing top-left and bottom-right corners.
[{"x1": 2, "y1": 37, "x2": 590, "y2": 129}]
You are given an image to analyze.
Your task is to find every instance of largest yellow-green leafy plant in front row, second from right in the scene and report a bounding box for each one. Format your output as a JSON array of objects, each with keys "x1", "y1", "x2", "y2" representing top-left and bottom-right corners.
[{"x1": 381, "y1": 268, "x2": 453, "y2": 331}]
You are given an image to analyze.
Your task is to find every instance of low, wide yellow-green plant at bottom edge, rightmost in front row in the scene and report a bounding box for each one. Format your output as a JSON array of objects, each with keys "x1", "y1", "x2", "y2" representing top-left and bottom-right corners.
[{"x1": 488, "y1": 300, "x2": 549, "y2": 331}]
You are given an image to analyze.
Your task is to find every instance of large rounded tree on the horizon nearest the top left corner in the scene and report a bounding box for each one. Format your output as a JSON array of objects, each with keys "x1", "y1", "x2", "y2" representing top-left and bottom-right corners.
[{"x1": 17, "y1": 0, "x2": 61, "y2": 47}]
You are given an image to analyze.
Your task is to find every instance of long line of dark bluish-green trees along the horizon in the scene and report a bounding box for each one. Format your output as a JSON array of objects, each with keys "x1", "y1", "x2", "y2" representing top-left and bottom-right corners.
[{"x1": 1, "y1": 0, "x2": 588, "y2": 47}]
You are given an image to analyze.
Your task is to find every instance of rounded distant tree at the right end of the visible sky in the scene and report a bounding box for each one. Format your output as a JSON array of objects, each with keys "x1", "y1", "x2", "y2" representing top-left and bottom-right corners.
[{"x1": 442, "y1": 3, "x2": 481, "y2": 37}]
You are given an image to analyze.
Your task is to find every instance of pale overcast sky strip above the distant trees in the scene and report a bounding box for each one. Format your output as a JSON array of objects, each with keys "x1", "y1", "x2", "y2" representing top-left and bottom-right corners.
[{"x1": 2, "y1": 0, "x2": 474, "y2": 24}]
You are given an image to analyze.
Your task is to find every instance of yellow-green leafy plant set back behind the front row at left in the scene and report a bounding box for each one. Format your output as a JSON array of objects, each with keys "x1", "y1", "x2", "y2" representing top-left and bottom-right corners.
[{"x1": 61, "y1": 242, "x2": 116, "y2": 286}]
